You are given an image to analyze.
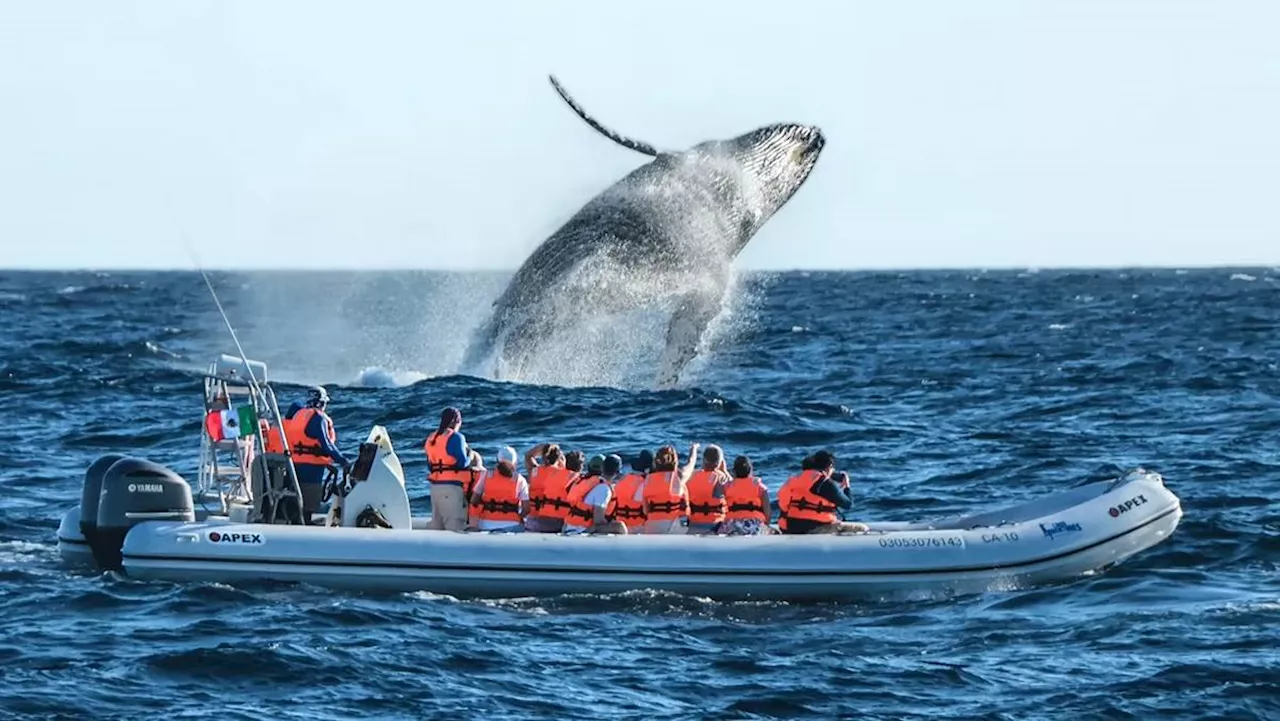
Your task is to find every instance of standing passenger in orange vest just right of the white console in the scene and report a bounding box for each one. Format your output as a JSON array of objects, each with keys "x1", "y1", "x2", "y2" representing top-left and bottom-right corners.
[{"x1": 422, "y1": 406, "x2": 484, "y2": 530}]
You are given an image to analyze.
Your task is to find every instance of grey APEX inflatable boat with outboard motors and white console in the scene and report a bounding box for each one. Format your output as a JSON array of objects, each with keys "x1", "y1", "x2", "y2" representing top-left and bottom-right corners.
[{"x1": 58, "y1": 356, "x2": 1181, "y2": 599}]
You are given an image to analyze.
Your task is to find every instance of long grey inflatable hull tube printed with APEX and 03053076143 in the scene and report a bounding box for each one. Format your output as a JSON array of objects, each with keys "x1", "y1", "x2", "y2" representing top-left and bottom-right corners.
[{"x1": 115, "y1": 474, "x2": 1181, "y2": 599}]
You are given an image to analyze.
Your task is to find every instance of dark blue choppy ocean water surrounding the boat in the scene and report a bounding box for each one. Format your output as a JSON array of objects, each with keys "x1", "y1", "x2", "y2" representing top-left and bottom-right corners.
[{"x1": 0, "y1": 271, "x2": 1280, "y2": 721}]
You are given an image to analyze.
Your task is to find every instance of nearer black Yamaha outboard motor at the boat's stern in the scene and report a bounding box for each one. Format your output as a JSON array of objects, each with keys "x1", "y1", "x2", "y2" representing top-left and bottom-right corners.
[{"x1": 90, "y1": 458, "x2": 196, "y2": 571}]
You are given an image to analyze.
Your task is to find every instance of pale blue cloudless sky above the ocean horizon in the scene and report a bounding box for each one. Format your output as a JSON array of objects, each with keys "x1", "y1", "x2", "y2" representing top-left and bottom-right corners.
[{"x1": 0, "y1": 0, "x2": 1280, "y2": 269}]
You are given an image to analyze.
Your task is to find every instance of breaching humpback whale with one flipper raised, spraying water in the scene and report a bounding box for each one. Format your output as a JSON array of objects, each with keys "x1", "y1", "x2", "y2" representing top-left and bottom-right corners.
[{"x1": 465, "y1": 76, "x2": 826, "y2": 387}]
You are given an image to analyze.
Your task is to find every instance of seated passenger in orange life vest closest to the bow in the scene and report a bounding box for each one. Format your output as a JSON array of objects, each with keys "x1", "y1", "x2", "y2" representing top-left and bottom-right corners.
[{"x1": 778, "y1": 451, "x2": 868, "y2": 534}]
